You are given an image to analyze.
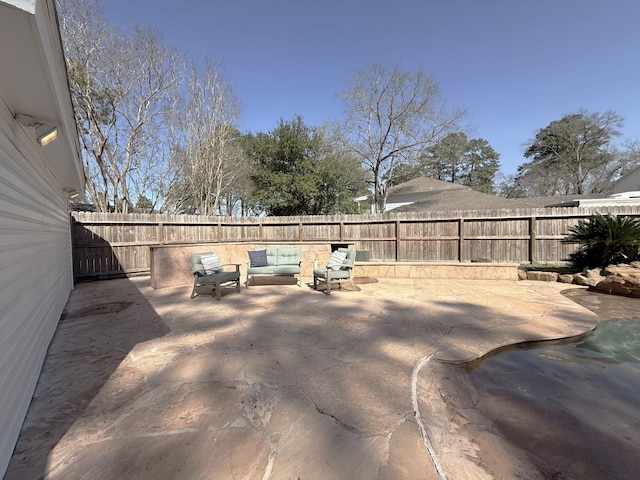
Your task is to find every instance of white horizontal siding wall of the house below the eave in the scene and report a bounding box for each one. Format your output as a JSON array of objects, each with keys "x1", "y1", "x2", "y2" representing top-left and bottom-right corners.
[{"x1": 0, "y1": 104, "x2": 73, "y2": 472}]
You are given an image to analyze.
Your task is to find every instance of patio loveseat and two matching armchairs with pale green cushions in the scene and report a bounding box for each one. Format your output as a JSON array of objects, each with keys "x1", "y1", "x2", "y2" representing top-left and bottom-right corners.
[{"x1": 190, "y1": 247, "x2": 355, "y2": 300}]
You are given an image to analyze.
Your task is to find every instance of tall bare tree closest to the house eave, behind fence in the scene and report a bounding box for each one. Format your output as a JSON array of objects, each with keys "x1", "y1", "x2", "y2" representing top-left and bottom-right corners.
[{"x1": 59, "y1": 0, "x2": 183, "y2": 212}]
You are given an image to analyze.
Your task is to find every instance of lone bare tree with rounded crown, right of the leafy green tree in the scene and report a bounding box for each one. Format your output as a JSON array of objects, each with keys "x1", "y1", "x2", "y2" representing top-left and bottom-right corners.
[{"x1": 341, "y1": 63, "x2": 465, "y2": 213}]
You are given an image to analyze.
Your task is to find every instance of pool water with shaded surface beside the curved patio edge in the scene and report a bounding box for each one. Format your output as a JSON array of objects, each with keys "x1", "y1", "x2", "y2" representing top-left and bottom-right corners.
[{"x1": 467, "y1": 317, "x2": 640, "y2": 480}]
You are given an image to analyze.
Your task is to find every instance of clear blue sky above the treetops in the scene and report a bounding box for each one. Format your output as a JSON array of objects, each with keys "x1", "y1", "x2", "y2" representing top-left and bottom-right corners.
[{"x1": 102, "y1": 0, "x2": 640, "y2": 174}]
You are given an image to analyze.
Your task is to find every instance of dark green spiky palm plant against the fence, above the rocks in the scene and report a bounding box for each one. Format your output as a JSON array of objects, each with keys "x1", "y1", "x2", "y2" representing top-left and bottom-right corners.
[{"x1": 563, "y1": 213, "x2": 640, "y2": 269}]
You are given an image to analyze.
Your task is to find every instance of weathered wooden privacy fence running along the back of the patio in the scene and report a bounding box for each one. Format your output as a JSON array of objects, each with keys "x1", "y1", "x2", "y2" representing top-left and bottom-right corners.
[{"x1": 71, "y1": 206, "x2": 640, "y2": 280}]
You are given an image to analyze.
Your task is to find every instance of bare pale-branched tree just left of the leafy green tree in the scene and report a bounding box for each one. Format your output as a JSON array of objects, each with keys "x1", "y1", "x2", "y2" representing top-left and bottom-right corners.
[{"x1": 168, "y1": 59, "x2": 249, "y2": 215}]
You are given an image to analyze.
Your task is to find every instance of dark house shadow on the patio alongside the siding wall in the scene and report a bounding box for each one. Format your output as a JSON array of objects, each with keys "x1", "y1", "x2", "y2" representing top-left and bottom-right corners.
[{"x1": 4, "y1": 279, "x2": 169, "y2": 480}]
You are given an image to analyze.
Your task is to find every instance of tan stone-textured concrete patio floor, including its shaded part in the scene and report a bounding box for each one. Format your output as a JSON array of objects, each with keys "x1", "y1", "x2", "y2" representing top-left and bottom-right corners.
[{"x1": 5, "y1": 277, "x2": 598, "y2": 480}]
